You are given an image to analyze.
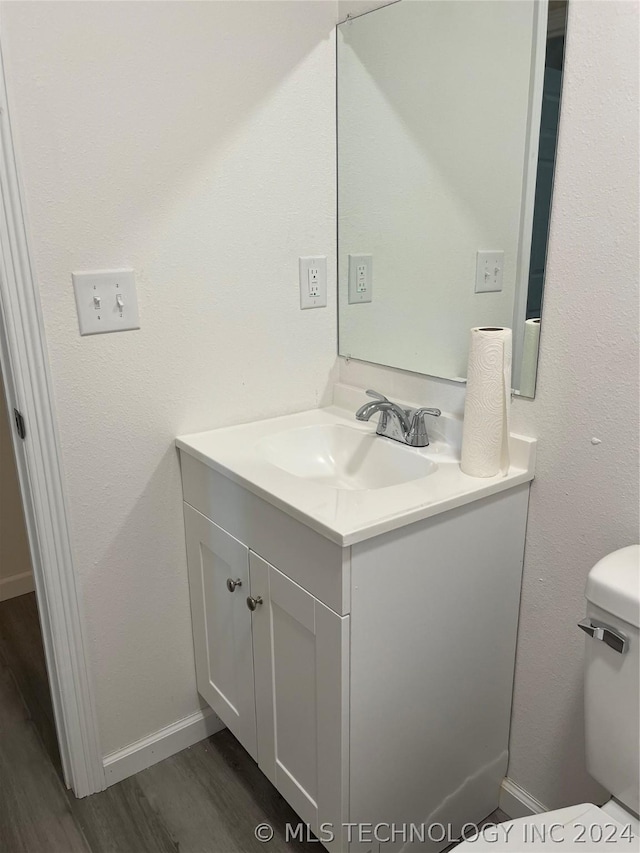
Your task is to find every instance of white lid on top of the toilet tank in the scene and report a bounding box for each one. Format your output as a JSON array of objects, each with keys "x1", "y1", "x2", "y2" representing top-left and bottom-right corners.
[{"x1": 586, "y1": 545, "x2": 640, "y2": 628}]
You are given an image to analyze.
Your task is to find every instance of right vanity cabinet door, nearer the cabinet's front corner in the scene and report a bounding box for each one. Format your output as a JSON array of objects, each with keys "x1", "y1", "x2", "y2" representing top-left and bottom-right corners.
[{"x1": 249, "y1": 551, "x2": 349, "y2": 850}]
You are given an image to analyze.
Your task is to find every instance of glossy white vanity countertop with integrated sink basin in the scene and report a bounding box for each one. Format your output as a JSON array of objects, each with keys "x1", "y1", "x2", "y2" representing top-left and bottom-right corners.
[{"x1": 176, "y1": 384, "x2": 536, "y2": 548}]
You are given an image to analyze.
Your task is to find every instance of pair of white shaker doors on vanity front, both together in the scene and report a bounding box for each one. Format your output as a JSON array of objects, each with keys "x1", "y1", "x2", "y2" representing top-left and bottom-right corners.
[{"x1": 184, "y1": 482, "x2": 349, "y2": 850}]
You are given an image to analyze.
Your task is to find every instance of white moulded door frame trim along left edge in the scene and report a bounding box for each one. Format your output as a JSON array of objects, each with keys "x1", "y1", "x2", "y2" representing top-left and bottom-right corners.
[{"x1": 0, "y1": 35, "x2": 106, "y2": 797}]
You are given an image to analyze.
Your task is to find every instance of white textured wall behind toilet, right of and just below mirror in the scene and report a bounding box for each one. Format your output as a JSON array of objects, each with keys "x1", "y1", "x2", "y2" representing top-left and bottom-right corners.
[{"x1": 341, "y1": 0, "x2": 639, "y2": 808}]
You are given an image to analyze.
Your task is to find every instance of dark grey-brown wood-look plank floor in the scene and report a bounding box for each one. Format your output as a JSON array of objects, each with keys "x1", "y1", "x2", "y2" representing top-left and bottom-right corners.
[{"x1": 0, "y1": 593, "x2": 507, "y2": 853}]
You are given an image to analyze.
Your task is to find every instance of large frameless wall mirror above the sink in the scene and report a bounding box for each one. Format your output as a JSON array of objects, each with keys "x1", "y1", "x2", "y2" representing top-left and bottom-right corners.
[{"x1": 338, "y1": 0, "x2": 567, "y2": 397}]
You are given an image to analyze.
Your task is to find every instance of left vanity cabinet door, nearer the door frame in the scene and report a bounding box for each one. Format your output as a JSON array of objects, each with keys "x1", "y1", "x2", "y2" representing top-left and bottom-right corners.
[{"x1": 184, "y1": 504, "x2": 257, "y2": 760}]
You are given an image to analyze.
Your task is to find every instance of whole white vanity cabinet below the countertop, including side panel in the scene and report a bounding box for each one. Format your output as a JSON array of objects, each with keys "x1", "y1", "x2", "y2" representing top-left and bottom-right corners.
[{"x1": 181, "y1": 449, "x2": 529, "y2": 853}]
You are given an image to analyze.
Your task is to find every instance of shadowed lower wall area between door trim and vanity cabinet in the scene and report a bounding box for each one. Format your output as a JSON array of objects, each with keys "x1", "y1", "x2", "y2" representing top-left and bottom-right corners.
[{"x1": 79, "y1": 444, "x2": 202, "y2": 754}]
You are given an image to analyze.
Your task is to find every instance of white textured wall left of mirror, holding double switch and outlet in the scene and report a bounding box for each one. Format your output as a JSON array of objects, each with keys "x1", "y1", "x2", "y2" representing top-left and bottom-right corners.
[{"x1": 1, "y1": 2, "x2": 336, "y2": 753}]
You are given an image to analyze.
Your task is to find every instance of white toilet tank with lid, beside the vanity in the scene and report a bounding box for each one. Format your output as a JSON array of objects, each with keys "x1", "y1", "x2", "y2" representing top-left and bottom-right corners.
[{"x1": 580, "y1": 545, "x2": 640, "y2": 815}]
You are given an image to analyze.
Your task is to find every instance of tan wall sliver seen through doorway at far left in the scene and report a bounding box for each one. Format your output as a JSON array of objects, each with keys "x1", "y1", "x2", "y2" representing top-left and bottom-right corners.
[{"x1": 0, "y1": 374, "x2": 33, "y2": 601}]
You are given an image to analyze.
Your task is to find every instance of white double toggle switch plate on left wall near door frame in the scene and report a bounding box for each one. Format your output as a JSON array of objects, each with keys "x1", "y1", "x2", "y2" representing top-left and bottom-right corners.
[{"x1": 71, "y1": 269, "x2": 140, "y2": 335}]
